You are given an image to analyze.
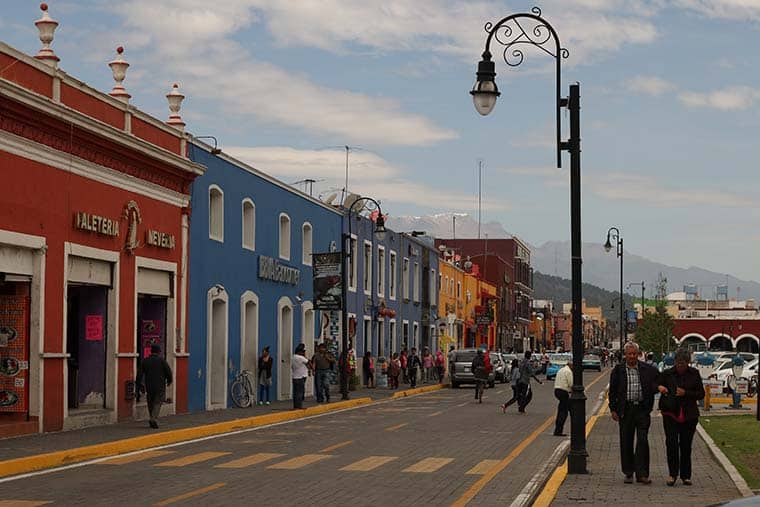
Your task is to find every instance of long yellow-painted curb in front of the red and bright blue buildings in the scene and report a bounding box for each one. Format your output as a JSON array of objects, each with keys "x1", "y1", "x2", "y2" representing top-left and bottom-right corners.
[{"x1": 0, "y1": 393, "x2": 372, "y2": 477}]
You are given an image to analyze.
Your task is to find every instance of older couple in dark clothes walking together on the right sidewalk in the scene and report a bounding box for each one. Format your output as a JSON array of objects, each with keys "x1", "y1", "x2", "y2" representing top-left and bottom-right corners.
[{"x1": 609, "y1": 342, "x2": 705, "y2": 486}]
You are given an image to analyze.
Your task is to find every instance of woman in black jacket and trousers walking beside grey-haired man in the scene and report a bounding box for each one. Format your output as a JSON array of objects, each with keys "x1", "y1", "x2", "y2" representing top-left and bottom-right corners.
[{"x1": 657, "y1": 349, "x2": 705, "y2": 486}]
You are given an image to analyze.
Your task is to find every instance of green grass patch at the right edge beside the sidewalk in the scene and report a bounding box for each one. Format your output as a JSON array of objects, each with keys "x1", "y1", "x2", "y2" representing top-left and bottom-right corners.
[{"x1": 699, "y1": 414, "x2": 760, "y2": 489}]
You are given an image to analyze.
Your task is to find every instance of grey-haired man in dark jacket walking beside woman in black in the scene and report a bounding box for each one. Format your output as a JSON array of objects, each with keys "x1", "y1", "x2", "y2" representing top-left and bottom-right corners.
[{"x1": 609, "y1": 342, "x2": 659, "y2": 484}]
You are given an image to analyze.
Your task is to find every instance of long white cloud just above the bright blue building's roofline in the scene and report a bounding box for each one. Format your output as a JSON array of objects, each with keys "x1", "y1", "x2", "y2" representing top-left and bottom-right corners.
[{"x1": 224, "y1": 146, "x2": 510, "y2": 213}]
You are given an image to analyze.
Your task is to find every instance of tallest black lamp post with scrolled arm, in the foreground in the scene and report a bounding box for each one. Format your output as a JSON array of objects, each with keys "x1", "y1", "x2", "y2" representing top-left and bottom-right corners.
[{"x1": 470, "y1": 7, "x2": 588, "y2": 474}]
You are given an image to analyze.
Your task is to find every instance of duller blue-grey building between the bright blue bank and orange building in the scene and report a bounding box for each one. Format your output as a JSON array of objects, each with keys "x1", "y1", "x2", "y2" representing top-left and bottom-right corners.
[{"x1": 343, "y1": 213, "x2": 439, "y2": 380}]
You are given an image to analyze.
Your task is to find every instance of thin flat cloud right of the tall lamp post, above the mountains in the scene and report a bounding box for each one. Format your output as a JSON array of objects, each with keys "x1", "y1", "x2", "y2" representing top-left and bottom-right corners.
[{"x1": 584, "y1": 173, "x2": 758, "y2": 208}]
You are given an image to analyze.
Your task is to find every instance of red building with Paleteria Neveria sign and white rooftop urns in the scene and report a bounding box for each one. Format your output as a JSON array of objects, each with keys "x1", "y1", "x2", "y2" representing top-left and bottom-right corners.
[{"x1": 0, "y1": 4, "x2": 203, "y2": 436}]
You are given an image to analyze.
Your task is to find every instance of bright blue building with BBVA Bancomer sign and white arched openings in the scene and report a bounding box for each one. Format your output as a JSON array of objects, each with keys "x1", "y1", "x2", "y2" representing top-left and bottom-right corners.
[{"x1": 188, "y1": 141, "x2": 342, "y2": 411}]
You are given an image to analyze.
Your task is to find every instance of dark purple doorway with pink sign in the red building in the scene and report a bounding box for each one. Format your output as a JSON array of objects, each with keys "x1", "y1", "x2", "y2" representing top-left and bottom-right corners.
[{"x1": 66, "y1": 285, "x2": 109, "y2": 408}]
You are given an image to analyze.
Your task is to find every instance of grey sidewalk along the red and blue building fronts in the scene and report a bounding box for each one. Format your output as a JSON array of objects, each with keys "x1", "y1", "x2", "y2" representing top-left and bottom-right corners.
[{"x1": 0, "y1": 383, "x2": 418, "y2": 461}]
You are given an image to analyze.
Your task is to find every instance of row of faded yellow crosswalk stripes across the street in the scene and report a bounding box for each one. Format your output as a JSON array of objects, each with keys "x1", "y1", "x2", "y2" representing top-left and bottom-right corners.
[{"x1": 95, "y1": 448, "x2": 499, "y2": 476}]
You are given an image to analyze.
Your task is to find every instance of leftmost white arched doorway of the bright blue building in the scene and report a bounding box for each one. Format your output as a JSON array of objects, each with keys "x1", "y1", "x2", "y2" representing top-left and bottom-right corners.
[{"x1": 206, "y1": 285, "x2": 229, "y2": 410}]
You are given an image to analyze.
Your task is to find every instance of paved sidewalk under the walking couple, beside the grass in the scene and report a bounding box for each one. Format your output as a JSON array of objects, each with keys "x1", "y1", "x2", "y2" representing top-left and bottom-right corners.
[{"x1": 551, "y1": 410, "x2": 741, "y2": 507}]
